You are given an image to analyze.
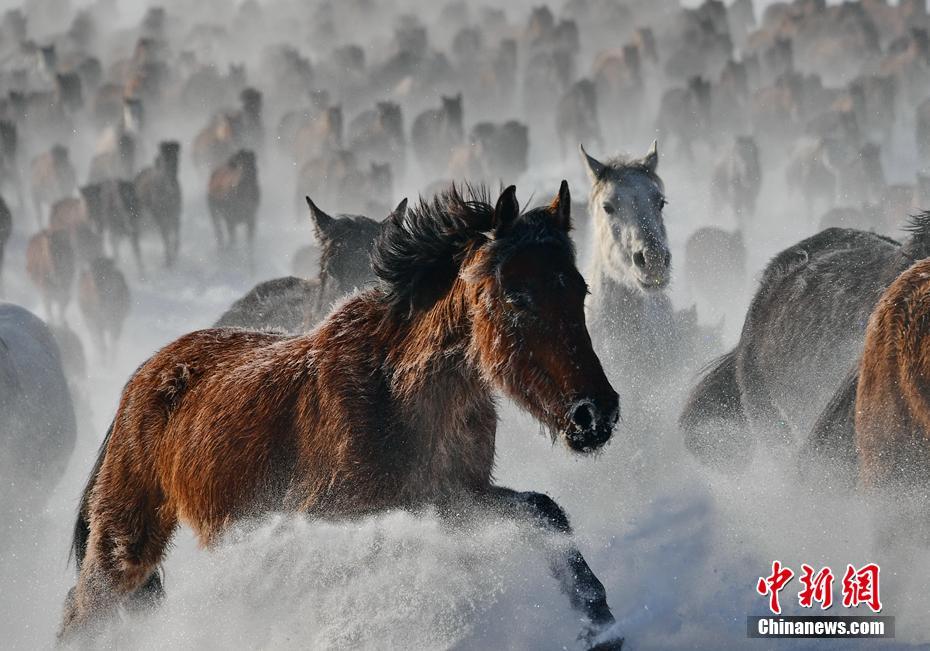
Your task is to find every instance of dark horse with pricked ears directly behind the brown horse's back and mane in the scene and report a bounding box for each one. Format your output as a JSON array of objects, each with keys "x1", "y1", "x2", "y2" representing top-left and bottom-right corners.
[{"x1": 213, "y1": 197, "x2": 392, "y2": 334}]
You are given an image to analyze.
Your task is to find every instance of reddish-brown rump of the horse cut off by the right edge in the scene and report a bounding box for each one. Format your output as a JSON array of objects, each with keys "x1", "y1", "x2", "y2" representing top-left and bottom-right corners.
[{"x1": 856, "y1": 259, "x2": 930, "y2": 487}]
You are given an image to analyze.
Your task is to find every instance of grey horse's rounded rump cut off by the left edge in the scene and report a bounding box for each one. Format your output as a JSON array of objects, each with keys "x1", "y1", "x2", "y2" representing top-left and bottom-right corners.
[{"x1": 0, "y1": 303, "x2": 76, "y2": 518}]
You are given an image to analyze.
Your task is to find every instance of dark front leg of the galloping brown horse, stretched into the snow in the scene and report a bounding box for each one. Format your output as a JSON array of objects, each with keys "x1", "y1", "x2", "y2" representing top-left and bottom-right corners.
[{"x1": 483, "y1": 486, "x2": 623, "y2": 651}]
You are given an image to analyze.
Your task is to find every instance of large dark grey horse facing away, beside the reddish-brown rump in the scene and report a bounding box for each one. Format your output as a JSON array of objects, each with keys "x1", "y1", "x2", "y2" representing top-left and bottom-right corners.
[{"x1": 679, "y1": 214, "x2": 930, "y2": 470}]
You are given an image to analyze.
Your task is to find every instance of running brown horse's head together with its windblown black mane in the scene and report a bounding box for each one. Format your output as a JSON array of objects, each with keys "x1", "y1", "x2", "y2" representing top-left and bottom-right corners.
[{"x1": 372, "y1": 181, "x2": 619, "y2": 452}]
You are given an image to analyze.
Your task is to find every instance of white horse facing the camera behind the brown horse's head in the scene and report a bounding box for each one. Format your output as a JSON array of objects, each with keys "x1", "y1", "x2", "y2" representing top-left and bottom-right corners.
[{"x1": 581, "y1": 142, "x2": 714, "y2": 422}]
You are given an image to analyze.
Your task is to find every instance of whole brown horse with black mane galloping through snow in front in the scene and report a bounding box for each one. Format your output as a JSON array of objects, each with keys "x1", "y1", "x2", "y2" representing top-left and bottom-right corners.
[{"x1": 61, "y1": 181, "x2": 620, "y2": 649}]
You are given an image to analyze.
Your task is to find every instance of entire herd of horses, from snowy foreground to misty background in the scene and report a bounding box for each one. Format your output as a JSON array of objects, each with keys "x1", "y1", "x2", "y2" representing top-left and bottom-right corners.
[{"x1": 0, "y1": 0, "x2": 930, "y2": 650}]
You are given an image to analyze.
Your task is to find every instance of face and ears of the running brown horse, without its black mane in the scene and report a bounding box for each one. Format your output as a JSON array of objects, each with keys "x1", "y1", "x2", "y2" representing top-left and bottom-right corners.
[{"x1": 461, "y1": 181, "x2": 620, "y2": 452}]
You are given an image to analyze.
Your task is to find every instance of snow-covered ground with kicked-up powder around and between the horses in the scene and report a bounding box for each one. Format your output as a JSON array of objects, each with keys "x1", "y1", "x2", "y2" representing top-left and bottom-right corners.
[{"x1": 0, "y1": 0, "x2": 930, "y2": 651}]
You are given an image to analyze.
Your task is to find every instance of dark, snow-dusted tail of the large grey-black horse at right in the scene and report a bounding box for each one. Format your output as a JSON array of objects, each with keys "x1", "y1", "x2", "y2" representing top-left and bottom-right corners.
[{"x1": 678, "y1": 348, "x2": 752, "y2": 471}]
